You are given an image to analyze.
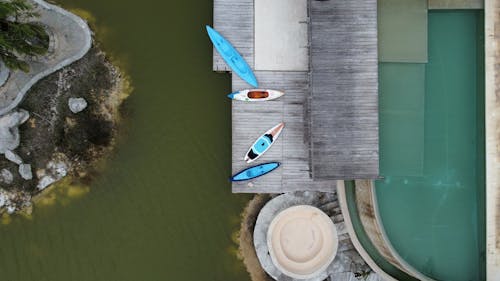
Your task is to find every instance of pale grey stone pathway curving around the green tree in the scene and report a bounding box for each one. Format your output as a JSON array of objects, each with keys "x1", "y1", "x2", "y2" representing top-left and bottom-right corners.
[{"x1": 0, "y1": 0, "x2": 92, "y2": 115}]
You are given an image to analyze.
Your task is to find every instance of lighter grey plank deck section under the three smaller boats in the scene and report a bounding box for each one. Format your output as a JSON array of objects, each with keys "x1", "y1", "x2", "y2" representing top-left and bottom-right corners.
[{"x1": 232, "y1": 71, "x2": 335, "y2": 193}]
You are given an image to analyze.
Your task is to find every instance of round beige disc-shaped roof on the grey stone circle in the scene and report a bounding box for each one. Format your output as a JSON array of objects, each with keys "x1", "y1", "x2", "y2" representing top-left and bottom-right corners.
[{"x1": 267, "y1": 205, "x2": 338, "y2": 279}]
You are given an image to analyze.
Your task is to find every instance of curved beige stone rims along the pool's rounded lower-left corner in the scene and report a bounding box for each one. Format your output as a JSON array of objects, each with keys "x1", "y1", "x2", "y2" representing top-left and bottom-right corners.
[{"x1": 337, "y1": 180, "x2": 433, "y2": 281}]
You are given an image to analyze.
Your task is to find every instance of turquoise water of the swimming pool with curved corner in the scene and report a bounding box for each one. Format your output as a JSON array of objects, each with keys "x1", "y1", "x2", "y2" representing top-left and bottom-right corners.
[{"x1": 376, "y1": 10, "x2": 485, "y2": 281}]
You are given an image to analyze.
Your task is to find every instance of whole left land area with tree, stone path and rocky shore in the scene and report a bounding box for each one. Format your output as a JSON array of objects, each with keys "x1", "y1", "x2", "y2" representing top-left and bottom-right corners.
[{"x1": 0, "y1": 0, "x2": 131, "y2": 214}]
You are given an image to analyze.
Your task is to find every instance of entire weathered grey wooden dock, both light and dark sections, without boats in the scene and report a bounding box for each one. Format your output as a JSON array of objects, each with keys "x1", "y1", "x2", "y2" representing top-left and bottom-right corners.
[{"x1": 213, "y1": 0, "x2": 378, "y2": 193}]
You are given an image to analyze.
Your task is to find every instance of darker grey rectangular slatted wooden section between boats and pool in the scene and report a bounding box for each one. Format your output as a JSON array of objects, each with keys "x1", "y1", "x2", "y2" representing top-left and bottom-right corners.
[{"x1": 309, "y1": 0, "x2": 379, "y2": 179}]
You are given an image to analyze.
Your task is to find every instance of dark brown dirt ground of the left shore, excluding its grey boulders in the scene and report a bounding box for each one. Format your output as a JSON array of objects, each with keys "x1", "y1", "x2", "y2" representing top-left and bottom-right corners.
[{"x1": 0, "y1": 43, "x2": 131, "y2": 213}]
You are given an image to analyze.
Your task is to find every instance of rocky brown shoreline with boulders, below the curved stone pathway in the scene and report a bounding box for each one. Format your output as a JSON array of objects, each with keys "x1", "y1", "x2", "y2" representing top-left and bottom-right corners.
[{"x1": 0, "y1": 44, "x2": 130, "y2": 214}]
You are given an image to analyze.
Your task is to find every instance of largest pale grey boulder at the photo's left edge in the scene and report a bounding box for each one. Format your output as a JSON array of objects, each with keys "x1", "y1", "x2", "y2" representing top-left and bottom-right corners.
[{"x1": 0, "y1": 109, "x2": 29, "y2": 153}]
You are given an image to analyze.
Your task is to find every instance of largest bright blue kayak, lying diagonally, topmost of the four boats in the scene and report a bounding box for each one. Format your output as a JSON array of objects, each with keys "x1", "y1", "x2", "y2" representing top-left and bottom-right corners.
[{"x1": 207, "y1": 25, "x2": 258, "y2": 87}]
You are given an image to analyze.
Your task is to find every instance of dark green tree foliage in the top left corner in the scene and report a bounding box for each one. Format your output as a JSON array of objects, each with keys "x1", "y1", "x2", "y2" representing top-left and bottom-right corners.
[{"x1": 0, "y1": 0, "x2": 49, "y2": 72}]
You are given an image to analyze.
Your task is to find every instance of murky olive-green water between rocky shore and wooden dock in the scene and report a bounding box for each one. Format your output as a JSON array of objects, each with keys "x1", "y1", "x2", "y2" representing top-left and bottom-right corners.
[{"x1": 0, "y1": 0, "x2": 249, "y2": 281}]
